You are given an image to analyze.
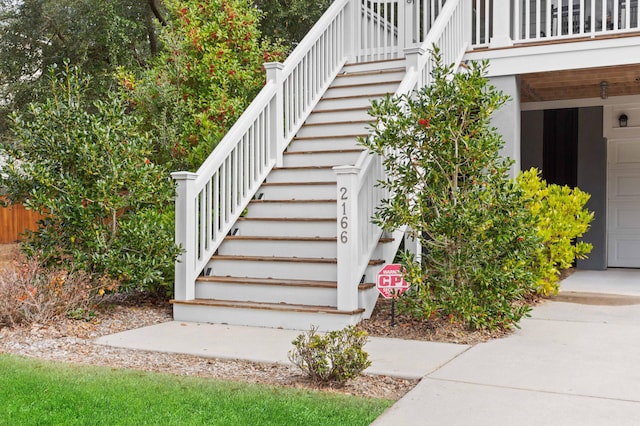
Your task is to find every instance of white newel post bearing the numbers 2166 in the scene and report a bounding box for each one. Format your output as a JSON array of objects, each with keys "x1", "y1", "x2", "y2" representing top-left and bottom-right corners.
[{"x1": 333, "y1": 166, "x2": 360, "y2": 311}]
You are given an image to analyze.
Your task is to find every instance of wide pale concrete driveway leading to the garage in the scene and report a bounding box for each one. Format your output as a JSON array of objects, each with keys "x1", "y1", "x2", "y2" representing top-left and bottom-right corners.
[{"x1": 374, "y1": 269, "x2": 640, "y2": 426}]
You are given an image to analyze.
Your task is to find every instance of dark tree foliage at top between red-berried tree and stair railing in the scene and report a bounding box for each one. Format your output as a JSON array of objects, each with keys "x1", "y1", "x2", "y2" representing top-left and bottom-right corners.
[{"x1": 255, "y1": 0, "x2": 333, "y2": 46}]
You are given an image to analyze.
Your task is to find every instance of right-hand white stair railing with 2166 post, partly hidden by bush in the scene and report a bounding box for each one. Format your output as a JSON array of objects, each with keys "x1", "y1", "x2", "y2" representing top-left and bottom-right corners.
[{"x1": 334, "y1": 0, "x2": 471, "y2": 311}]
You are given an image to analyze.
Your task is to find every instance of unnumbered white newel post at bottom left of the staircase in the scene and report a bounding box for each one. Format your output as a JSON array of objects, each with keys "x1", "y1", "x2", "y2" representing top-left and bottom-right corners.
[{"x1": 171, "y1": 172, "x2": 198, "y2": 300}]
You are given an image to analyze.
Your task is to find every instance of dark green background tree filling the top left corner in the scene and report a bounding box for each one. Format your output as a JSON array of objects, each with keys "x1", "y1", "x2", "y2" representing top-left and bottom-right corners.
[{"x1": 0, "y1": 0, "x2": 165, "y2": 131}]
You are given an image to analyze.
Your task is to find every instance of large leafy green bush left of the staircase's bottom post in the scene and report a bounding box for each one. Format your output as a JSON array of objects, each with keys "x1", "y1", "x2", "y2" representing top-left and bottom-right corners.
[{"x1": 0, "y1": 66, "x2": 178, "y2": 291}]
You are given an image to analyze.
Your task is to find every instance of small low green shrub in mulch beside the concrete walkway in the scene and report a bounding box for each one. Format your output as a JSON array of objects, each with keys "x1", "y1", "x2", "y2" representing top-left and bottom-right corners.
[{"x1": 288, "y1": 326, "x2": 371, "y2": 383}]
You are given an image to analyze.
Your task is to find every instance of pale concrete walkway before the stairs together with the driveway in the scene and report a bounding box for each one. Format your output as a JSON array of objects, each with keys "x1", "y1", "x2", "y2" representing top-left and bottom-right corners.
[{"x1": 98, "y1": 269, "x2": 640, "y2": 426}]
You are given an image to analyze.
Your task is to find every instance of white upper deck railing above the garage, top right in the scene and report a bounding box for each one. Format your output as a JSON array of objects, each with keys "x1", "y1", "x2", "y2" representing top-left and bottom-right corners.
[{"x1": 472, "y1": 0, "x2": 640, "y2": 47}]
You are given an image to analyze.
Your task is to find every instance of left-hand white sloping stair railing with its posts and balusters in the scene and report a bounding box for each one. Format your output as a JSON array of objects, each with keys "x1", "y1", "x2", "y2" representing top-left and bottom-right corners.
[{"x1": 172, "y1": 0, "x2": 355, "y2": 300}]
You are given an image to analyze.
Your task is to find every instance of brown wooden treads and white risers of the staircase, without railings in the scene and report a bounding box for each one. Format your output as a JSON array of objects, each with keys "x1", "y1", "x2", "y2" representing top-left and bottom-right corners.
[{"x1": 174, "y1": 60, "x2": 405, "y2": 330}]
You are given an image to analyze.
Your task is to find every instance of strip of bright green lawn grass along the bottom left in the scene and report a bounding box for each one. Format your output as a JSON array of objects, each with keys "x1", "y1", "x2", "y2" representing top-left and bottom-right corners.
[{"x1": 0, "y1": 354, "x2": 392, "y2": 426}]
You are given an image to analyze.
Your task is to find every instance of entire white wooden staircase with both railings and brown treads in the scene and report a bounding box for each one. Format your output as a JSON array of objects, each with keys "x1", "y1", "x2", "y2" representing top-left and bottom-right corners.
[{"x1": 172, "y1": 0, "x2": 471, "y2": 330}]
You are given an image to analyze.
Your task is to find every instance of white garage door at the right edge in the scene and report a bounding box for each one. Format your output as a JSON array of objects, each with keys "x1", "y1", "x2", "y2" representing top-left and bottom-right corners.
[{"x1": 607, "y1": 139, "x2": 640, "y2": 268}]
